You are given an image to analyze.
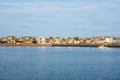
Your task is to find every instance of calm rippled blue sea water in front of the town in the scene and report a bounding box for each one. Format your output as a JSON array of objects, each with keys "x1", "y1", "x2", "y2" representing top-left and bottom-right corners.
[{"x1": 0, "y1": 47, "x2": 120, "y2": 80}]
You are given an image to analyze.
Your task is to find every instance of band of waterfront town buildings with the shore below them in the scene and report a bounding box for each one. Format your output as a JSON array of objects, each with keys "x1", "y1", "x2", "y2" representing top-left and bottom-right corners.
[{"x1": 0, "y1": 36, "x2": 120, "y2": 47}]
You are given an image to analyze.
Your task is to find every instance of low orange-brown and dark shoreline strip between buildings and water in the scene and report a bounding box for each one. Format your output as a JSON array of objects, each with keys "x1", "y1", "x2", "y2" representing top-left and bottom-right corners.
[{"x1": 0, "y1": 44, "x2": 120, "y2": 48}]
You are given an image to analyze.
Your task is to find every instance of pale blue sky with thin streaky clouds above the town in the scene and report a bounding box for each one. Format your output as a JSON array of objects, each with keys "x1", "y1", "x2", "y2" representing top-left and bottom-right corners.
[{"x1": 0, "y1": 0, "x2": 120, "y2": 37}]
